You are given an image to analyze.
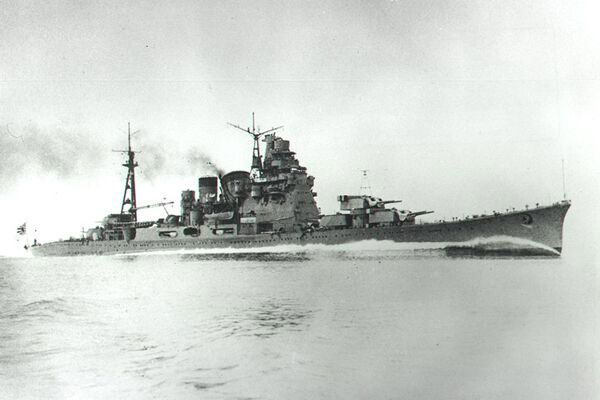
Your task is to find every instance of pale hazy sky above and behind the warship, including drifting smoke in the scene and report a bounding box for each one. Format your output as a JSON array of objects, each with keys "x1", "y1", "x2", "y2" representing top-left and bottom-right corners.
[{"x1": 0, "y1": 0, "x2": 600, "y2": 254}]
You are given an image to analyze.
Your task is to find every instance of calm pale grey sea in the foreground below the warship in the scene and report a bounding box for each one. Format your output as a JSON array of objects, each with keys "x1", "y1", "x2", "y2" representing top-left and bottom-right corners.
[{"x1": 0, "y1": 243, "x2": 600, "y2": 400}]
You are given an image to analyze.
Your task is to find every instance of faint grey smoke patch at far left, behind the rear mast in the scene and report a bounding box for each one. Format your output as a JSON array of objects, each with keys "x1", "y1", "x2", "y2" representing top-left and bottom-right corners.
[{"x1": 0, "y1": 124, "x2": 104, "y2": 185}]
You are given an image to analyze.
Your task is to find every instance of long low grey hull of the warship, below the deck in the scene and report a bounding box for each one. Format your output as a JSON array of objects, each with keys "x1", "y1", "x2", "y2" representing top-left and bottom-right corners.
[{"x1": 32, "y1": 201, "x2": 570, "y2": 256}]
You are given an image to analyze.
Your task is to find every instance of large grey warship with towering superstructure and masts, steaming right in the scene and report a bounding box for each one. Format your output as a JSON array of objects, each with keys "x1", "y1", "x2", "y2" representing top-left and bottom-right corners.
[{"x1": 30, "y1": 115, "x2": 571, "y2": 256}]
